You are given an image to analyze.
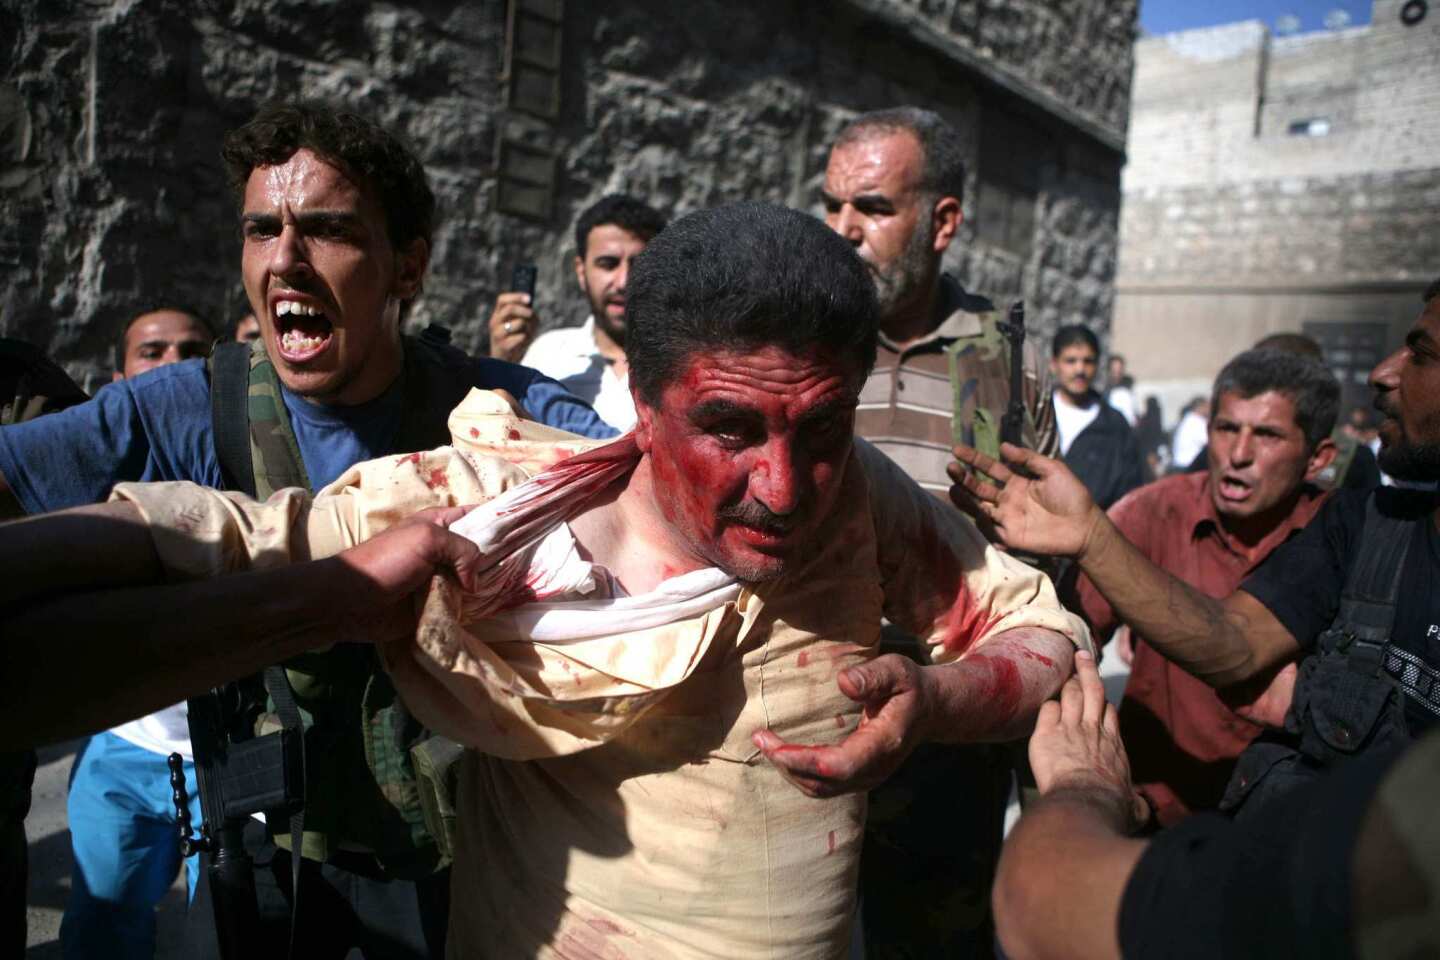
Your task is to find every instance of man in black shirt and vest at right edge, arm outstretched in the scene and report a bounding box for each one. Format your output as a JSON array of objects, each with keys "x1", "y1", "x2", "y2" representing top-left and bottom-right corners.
[{"x1": 952, "y1": 281, "x2": 1440, "y2": 809}]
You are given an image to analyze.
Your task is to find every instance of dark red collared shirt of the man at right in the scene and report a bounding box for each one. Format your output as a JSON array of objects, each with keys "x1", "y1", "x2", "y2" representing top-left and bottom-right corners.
[{"x1": 1076, "y1": 472, "x2": 1325, "y2": 826}]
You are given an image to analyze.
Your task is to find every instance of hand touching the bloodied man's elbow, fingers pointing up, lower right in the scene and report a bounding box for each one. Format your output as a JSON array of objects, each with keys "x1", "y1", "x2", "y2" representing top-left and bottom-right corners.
[{"x1": 1030, "y1": 651, "x2": 1148, "y2": 825}]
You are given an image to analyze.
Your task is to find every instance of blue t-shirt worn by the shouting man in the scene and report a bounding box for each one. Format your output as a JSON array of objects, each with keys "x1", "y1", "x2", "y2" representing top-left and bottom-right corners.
[{"x1": 0, "y1": 357, "x2": 615, "y2": 514}]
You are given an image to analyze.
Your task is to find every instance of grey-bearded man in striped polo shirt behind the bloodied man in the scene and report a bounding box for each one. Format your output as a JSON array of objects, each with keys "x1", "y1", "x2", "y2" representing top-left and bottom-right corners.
[{"x1": 821, "y1": 107, "x2": 1060, "y2": 960}]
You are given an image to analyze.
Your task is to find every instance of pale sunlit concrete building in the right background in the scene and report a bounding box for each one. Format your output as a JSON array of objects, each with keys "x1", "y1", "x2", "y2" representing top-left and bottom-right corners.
[{"x1": 1113, "y1": 0, "x2": 1440, "y2": 422}]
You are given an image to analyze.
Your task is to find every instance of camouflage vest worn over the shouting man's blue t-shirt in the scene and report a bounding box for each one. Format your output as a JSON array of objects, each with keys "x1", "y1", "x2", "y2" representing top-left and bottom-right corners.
[{"x1": 212, "y1": 335, "x2": 474, "y2": 878}]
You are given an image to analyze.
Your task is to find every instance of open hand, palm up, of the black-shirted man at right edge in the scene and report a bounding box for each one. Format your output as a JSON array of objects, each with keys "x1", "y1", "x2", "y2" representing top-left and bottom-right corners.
[{"x1": 946, "y1": 443, "x2": 1104, "y2": 557}]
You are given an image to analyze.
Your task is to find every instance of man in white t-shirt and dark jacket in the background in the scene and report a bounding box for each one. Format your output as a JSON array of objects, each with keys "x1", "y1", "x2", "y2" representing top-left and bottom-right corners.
[{"x1": 1050, "y1": 324, "x2": 1145, "y2": 510}]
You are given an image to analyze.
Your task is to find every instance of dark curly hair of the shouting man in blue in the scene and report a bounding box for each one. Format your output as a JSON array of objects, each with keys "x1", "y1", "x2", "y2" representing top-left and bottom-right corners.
[{"x1": 220, "y1": 101, "x2": 435, "y2": 259}]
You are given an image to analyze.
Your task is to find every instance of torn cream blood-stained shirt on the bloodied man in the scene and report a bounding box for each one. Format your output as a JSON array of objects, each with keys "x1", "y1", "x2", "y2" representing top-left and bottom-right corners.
[{"x1": 117, "y1": 393, "x2": 1089, "y2": 957}]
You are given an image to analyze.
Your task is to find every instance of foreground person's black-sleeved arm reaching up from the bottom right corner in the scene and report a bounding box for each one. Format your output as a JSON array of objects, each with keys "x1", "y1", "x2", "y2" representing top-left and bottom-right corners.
[{"x1": 995, "y1": 644, "x2": 1440, "y2": 960}]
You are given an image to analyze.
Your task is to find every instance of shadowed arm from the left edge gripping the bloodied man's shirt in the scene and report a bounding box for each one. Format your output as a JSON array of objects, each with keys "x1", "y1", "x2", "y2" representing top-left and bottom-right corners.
[{"x1": 0, "y1": 504, "x2": 478, "y2": 750}]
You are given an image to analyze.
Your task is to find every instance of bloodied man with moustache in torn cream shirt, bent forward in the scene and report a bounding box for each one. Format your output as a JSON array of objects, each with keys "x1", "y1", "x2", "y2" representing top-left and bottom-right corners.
[{"x1": 19, "y1": 204, "x2": 1089, "y2": 957}]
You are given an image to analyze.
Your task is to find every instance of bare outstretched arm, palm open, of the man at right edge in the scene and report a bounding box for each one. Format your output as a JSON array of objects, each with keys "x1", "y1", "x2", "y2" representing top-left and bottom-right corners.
[{"x1": 950, "y1": 443, "x2": 1299, "y2": 687}]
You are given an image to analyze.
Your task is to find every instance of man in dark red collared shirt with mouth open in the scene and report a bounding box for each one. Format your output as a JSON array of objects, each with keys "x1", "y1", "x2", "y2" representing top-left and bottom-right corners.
[{"x1": 979, "y1": 350, "x2": 1339, "y2": 826}]
